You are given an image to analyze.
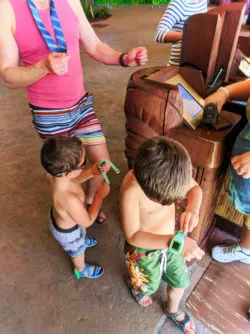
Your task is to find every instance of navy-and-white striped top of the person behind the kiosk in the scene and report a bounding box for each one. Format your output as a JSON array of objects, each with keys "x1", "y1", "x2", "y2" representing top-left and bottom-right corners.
[{"x1": 155, "y1": 0, "x2": 207, "y2": 66}]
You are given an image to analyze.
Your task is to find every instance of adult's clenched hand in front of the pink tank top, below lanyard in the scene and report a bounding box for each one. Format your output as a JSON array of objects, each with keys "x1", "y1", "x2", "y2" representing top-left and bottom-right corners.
[{"x1": 45, "y1": 52, "x2": 70, "y2": 75}]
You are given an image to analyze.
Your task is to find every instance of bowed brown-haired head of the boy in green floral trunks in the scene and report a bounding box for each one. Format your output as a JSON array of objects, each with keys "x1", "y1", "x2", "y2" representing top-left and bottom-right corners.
[{"x1": 134, "y1": 137, "x2": 192, "y2": 205}]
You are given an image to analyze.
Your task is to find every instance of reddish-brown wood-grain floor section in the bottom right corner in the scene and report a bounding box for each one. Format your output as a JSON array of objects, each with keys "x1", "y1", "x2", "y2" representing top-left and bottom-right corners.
[{"x1": 186, "y1": 262, "x2": 250, "y2": 334}]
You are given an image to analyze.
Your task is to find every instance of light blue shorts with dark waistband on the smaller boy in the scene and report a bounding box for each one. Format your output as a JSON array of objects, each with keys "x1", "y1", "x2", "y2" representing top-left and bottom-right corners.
[{"x1": 49, "y1": 209, "x2": 87, "y2": 257}]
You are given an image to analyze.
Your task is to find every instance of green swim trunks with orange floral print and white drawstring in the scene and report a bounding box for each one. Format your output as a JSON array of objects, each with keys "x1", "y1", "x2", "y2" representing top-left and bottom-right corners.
[{"x1": 124, "y1": 243, "x2": 190, "y2": 295}]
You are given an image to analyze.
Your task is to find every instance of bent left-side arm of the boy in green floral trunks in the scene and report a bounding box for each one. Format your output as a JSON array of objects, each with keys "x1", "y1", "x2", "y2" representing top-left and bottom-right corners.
[{"x1": 120, "y1": 185, "x2": 174, "y2": 249}]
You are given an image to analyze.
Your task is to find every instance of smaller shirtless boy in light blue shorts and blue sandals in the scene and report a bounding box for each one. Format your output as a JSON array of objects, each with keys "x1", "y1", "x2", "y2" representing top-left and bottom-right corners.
[{"x1": 41, "y1": 136, "x2": 109, "y2": 278}]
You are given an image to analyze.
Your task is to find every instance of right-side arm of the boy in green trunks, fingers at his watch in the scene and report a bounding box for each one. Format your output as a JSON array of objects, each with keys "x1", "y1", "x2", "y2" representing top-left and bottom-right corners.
[{"x1": 180, "y1": 179, "x2": 202, "y2": 233}]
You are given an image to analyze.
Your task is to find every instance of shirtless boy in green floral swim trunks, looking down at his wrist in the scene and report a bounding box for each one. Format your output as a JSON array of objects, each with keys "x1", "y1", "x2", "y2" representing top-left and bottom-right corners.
[{"x1": 120, "y1": 137, "x2": 204, "y2": 334}]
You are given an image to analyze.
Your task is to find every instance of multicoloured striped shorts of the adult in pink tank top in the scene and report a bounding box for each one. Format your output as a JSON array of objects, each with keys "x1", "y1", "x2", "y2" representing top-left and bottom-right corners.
[{"x1": 30, "y1": 93, "x2": 105, "y2": 145}]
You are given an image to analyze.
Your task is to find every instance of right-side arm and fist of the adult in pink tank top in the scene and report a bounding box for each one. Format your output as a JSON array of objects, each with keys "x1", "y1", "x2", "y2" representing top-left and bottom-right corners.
[{"x1": 68, "y1": 0, "x2": 147, "y2": 67}]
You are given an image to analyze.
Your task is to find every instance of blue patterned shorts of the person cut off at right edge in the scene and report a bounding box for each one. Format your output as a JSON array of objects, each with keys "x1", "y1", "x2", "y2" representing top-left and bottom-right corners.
[{"x1": 228, "y1": 123, "x2": 250, "y2": 224}]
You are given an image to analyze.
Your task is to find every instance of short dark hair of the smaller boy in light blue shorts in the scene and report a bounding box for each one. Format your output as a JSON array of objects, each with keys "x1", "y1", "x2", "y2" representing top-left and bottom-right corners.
[{"x1": 41, "y1": 136, "x2": 83, "y2": 176}]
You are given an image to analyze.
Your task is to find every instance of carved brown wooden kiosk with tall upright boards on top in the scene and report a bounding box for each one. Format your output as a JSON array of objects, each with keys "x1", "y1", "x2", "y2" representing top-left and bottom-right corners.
[{"x1": 124, "y1": 3, "x2": 245, "y2": 245}]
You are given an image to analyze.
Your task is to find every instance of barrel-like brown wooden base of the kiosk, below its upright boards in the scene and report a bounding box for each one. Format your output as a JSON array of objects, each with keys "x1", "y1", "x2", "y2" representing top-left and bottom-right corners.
[{"x1": 124, "y1": 67, "x2": 241, "y2": 244}]
